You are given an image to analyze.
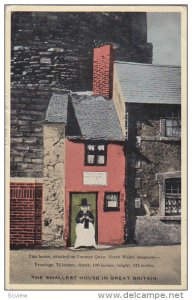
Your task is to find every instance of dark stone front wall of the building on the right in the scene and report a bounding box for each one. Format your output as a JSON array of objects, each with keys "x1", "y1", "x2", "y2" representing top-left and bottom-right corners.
[{"x1": 126, "y1": 104, "x2": 181, "y2": 244}]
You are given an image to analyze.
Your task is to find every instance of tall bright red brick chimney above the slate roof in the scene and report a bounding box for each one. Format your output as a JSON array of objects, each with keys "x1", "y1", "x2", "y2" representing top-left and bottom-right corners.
[{"x1": 93, "y1": 45, "x2": 114, "y2": 99}]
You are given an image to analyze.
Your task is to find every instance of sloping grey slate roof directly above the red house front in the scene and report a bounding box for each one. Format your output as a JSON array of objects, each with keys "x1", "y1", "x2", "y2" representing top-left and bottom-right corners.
[{"x1": 72, "y1": 95, "x2": 124, "y2": 141}]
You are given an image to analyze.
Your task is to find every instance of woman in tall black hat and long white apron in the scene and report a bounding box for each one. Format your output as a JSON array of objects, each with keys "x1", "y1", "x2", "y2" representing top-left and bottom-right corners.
[{"x1": 74, "y1": 198, "x2": 96, "y2": 248}]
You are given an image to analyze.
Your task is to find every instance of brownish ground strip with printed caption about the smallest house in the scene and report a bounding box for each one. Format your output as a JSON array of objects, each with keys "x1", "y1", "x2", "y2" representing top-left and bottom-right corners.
[{"x1": 9, "y1": 245, "x2": 181, "y2": 289}]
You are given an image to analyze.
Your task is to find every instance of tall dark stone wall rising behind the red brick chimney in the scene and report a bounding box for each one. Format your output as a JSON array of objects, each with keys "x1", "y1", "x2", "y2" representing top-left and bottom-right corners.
[{"x1": 11, "y1": 12, "x2": 152, "y2": 177}]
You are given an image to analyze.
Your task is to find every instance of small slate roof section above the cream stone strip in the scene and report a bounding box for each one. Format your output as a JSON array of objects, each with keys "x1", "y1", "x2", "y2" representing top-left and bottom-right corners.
[{"x1": 44, "y1": 93, "x2": 68, "y2": 123}]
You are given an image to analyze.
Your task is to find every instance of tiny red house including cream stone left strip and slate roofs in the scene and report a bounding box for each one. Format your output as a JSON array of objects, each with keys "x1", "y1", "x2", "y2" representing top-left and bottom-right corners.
[{"x1": 43, "y1": 92, "x2": 125, "y2": 247}]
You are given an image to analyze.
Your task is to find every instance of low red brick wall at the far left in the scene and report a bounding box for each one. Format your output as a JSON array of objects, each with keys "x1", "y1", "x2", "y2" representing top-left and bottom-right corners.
[{"x1": 10, "y1": 183, "x2": 43, "y2": 247}]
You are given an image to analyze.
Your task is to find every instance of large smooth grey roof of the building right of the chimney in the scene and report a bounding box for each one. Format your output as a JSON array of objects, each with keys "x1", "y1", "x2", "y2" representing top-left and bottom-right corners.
[{"x1": 115, "y1": 61, "x2": 181, "y2": 104}]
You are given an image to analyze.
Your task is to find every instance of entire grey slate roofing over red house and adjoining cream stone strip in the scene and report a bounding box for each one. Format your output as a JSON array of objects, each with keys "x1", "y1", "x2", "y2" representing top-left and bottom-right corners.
[{"x1": 45, "y1": 92, "x2": 124, "y2": 141}]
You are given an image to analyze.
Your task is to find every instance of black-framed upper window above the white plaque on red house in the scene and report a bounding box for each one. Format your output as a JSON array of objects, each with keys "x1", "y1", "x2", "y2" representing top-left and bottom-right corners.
[{"x1": 85, "y1": 143, "x2": 107, "y2": 166}]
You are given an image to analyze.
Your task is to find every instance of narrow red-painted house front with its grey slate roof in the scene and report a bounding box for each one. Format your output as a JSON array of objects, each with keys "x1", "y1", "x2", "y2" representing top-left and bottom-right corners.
[{"x1": 46, "y1": 93, "x2": 125, "y2": 246}]
